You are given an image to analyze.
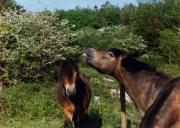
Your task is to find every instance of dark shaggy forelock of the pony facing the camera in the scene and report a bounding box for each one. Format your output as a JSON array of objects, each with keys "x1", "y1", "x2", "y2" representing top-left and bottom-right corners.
[{"x1": 59, "y1": 60, "x2": 79, "y2": 79}]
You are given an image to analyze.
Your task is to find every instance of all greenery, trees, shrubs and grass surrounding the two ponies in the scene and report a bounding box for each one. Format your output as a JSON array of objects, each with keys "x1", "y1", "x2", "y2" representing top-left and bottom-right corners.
[{"x1": 0, "y1": 0, "x2": 180, "y2": 128}]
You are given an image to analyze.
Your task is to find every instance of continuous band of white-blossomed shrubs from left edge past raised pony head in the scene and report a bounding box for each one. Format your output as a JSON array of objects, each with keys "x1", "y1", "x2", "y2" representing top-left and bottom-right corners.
[{"x1": 0, "y1": 11, "x2": 146, "y2": 83}]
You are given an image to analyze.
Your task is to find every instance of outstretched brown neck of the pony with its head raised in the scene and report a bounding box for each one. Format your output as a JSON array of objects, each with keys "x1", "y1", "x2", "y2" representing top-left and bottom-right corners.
[{"x1": 112, "y1": 58, "x2": 169, "y2": 116}]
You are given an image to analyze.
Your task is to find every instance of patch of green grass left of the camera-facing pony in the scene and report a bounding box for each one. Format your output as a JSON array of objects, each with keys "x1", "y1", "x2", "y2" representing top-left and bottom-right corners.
[{"x1": 0, "y1": 84, "x2": 63, "y2": 128}]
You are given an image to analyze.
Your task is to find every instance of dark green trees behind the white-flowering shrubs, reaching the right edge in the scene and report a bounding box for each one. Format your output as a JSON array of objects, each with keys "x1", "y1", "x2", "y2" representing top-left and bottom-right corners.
[{"x1": 56, "y1": 0, "x2": 180, "y2": 64}]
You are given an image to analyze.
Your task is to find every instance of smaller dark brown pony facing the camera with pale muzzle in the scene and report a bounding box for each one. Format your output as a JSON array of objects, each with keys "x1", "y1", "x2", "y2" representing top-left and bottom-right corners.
[{"x1": 57, "y1": 60, "x2": 91, "y2": 128}]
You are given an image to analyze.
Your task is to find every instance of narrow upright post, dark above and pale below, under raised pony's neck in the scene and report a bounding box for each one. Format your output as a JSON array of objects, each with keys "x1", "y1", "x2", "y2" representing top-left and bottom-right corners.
[{"x1": 120, "y1": 85, "x2": 126, "y2": 128}]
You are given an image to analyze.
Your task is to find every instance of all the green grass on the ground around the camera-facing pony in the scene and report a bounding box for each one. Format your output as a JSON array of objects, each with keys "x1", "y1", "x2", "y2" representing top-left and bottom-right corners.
[{"x1": 0, "y1": 68, "x2": 140, "y2": 128}]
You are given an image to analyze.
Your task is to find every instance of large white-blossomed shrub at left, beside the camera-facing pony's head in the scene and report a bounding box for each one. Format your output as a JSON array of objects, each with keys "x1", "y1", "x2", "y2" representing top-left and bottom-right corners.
[{"x1": 0, "y1": 11, "x2": 79, "y2": 81}]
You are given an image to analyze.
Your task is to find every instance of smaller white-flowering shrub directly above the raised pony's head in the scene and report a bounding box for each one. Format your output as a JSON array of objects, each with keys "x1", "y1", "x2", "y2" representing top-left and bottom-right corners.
[{"x1": 78, "y1": 26, "x2": 146, "y2": 53}]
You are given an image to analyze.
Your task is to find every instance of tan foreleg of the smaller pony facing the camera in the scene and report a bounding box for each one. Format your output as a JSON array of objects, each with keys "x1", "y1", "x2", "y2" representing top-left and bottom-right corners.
[{"x1": 64, "y1": 103, "x2": 75, "y2": 128}]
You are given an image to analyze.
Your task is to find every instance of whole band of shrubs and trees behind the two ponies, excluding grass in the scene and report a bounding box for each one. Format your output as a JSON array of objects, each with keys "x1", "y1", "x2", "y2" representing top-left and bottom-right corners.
[{"x1": 0, "y1": 0, "x2": 180, "y2": 85}]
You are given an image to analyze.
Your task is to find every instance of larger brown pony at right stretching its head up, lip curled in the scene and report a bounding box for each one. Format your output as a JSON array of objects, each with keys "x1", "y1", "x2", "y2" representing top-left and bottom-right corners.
[{"x1": 83, "y1": 49, "x2": 180, "y2": 128}]
